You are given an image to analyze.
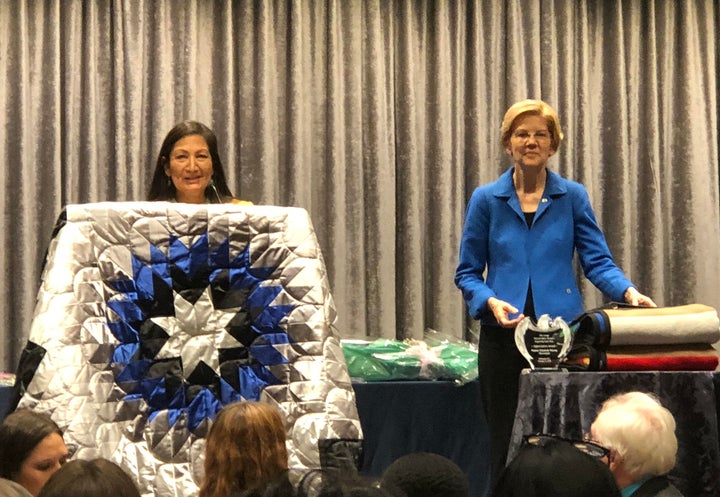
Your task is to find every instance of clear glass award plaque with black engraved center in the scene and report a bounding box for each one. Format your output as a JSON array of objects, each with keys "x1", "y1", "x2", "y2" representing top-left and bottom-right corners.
[{"x1": 515, "y1": 314, "x2": 572, "y2": 370}]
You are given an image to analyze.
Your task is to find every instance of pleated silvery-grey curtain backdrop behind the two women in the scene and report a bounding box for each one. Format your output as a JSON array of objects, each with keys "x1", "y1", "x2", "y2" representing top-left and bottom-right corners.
[{"x1": 0, "y1": 0, "x2": 720, "y2": 371}]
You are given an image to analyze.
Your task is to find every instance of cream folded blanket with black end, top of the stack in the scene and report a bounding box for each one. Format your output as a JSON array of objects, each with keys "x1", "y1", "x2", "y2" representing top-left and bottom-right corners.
[{"x1": 570, "y1": 304, "x2": 720, "y2": 348}]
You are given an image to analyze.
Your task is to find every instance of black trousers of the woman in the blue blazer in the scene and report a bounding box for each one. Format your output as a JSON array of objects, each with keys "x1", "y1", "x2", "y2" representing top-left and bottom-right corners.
[{"x1": 478, "y1": 326, "x2": 529, "y2": 488}]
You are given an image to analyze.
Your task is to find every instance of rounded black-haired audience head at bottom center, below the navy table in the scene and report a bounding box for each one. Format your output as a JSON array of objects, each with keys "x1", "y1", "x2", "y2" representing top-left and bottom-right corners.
[{"x1": 380, "y1": 452, "x2": 469, "y2": 497}]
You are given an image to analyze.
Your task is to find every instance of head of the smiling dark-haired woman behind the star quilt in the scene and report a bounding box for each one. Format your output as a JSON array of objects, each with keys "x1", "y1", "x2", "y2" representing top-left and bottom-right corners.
[{"x1": 148, "y1": 121, "x2": 232, "y2": 203}]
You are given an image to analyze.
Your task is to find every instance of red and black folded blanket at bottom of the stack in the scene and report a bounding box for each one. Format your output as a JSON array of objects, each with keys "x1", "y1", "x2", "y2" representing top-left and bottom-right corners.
[{"x1": 563, "y1": 343, "x2": 719, "y2": 371}]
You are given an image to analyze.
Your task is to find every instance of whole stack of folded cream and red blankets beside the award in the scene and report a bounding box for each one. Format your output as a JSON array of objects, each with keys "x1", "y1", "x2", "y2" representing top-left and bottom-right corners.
[{"x1": 565, "y1": 304, "x2": 720, "y2": 371}]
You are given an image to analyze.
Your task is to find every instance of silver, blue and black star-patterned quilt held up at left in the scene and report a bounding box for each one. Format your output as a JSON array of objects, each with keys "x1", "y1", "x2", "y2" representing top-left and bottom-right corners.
[{"x1": 18, "y1": 202, "x2": 362, "y2": 497}]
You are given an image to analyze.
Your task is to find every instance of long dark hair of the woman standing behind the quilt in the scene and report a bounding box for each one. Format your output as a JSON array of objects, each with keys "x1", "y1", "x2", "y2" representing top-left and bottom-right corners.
[{"x1": 147, "y1": 121, "x2": 233, "y2": 203}]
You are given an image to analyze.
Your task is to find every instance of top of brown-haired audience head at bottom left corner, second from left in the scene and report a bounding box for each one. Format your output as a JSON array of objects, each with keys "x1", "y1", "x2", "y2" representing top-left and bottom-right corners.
[{"x1": 39, "y1": 459, "x2": 140, "y2": 497}]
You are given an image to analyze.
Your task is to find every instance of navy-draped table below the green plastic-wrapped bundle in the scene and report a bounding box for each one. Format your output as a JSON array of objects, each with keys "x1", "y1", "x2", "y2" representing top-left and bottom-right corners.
[{"x1": 353, "y1": 381, "x2": 490, "y2": 497}]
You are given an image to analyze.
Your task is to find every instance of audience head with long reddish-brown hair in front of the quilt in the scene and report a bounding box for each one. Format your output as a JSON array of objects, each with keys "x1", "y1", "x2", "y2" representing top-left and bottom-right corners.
[{"x1": 199, "y1": 402, "x2": 288, "y2": 497}]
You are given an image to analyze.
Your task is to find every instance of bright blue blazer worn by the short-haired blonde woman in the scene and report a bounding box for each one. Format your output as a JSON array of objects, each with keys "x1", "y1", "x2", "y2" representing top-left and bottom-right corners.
[{"x1": 455, "y1": 168, "x2": 633, "y2": 324}]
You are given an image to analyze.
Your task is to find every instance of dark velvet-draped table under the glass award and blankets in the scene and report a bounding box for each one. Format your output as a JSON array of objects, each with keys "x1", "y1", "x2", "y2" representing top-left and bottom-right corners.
[{"x1": 508, "y1": 370, "x2": 720, "y2": 497}]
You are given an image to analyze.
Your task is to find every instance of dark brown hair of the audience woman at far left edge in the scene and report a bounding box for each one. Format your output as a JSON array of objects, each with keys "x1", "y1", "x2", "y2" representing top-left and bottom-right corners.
[{"x1": 0, "y1": 409, "x2": 62, "y2": 480}]
